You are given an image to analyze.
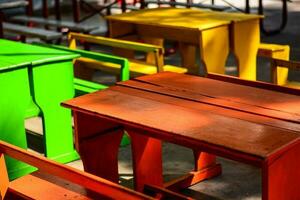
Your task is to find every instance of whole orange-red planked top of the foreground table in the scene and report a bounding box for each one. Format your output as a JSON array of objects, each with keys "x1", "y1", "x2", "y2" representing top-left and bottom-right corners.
[{"x1": 63, "y1": 72, "x2": 300, "y2": 159}]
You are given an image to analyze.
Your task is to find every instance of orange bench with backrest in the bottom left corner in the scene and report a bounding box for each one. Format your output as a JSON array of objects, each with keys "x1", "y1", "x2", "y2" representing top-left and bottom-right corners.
[{"x1": 0, "y1": 141, "x2": 151, "y2": 199}]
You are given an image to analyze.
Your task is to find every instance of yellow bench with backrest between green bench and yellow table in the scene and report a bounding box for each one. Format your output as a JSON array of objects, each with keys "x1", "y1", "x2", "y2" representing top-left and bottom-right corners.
[{"x1": 68, "y1": 33, "x2": 187, "y2": 78}]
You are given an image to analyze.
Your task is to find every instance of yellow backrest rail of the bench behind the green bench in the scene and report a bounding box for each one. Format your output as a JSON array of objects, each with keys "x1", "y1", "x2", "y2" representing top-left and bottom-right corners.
[{"x1": 68, "y1": 32, "x2": 164, "y2": 72}]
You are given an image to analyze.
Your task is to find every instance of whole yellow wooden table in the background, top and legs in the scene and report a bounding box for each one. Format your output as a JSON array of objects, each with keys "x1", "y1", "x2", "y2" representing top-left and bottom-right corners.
[{"x1": 106, "y1": 8, "x2": 261, "y2": 80}]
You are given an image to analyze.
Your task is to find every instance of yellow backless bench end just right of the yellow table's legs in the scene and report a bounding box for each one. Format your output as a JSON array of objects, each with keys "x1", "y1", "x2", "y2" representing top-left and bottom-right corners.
[{"x1": 257, "y1": 43, "x2": 290, "y2": 85}]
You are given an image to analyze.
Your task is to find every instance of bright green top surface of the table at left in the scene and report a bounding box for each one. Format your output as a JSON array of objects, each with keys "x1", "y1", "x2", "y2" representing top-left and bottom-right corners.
[{"x1": 0, "y1": 39, "x2": 79, "y2": 71}]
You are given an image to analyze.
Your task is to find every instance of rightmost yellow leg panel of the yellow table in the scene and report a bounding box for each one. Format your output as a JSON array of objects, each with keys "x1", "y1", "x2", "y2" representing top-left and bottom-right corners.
[{"x1": 231, "y1": 19, "x2": 260, "y2": 80}]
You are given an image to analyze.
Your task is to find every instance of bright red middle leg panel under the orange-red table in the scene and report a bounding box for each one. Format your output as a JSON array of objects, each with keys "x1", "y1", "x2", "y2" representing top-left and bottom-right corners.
[{"x1": 127, "y1": 129, "x2": 163, "y2": 192}]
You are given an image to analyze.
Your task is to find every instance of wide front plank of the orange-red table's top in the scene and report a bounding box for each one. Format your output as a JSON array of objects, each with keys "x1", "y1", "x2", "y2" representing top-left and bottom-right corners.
[{"x1": 63, "y1": 86, "x2": 299, "y2": 158}]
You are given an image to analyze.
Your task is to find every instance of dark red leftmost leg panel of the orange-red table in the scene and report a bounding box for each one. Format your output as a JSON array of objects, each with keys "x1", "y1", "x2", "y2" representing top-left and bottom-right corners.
[{"x1": 73, "y1": 111, "x2": 124, "y2": 183}]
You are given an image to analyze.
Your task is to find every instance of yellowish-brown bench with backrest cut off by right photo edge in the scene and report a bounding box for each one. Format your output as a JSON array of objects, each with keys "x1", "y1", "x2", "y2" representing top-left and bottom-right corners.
[{"x1": 271, "y1": 59, "x2": 300, "y2": 89}]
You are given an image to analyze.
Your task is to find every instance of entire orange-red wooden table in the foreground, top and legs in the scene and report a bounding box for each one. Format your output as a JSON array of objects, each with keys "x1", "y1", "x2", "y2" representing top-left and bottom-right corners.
[{"x1": 63, "y1": 72, "x2": 300, "y2": 200}]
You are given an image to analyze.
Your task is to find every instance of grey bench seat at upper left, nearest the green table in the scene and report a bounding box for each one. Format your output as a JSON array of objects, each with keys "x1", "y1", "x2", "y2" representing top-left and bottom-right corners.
[{"x1": 3, "y1": 22, "x2": 62, "y2": 41}]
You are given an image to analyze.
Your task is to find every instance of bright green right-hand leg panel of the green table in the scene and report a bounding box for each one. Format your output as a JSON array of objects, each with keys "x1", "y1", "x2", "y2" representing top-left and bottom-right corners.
[{"x1": 31, "y1": 61, "x2": 78, "y2": 163}]
